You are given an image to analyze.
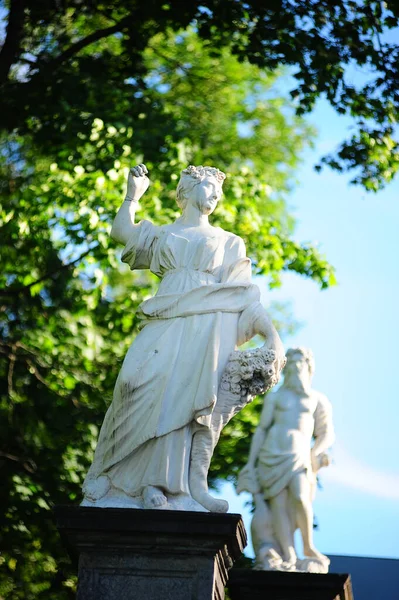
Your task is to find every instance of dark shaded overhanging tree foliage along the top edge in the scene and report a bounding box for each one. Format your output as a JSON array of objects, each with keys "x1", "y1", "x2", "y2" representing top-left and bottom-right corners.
[{"x1": 0, "y1": 0, "x2": 399, "y2": 190}]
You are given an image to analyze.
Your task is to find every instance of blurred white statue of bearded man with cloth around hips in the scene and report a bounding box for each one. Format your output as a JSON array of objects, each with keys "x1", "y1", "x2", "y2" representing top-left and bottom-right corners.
[{"x1": 237, "y1": 348, "x2": 334, "y2": 573}]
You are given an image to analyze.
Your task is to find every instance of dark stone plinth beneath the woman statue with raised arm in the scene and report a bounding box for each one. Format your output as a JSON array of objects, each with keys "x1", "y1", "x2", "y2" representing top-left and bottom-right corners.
[{"x1": 55, "y1": 506, "x2": 246, "y2": 600}]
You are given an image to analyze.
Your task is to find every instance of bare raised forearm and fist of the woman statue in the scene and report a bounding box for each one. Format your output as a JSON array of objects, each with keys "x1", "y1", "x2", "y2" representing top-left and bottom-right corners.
[{"x1": 111, "y1": 164, "x2": 150, "y2": 245}]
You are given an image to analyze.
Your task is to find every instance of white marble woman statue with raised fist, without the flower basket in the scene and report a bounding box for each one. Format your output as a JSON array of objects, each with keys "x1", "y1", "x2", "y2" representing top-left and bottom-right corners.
[{"x1": 83, "y1": 164, "x2": 284, "y2": 512}]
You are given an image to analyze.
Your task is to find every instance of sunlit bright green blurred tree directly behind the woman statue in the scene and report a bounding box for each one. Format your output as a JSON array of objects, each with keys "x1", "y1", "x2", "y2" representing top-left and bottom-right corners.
[{"x1": 0, "y1": 31, "x2": 340, "y2": 600}]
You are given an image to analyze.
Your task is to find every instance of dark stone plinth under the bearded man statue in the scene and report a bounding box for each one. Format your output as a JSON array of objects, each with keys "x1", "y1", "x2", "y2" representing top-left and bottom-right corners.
[{"x1": 227, "y1": 569, "x2": 353, "y2": 600}]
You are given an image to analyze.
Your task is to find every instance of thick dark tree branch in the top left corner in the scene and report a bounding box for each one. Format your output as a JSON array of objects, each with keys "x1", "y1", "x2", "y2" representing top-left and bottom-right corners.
[{"x1": 0, "y1": 0, "x2": 25, "y2": 84}]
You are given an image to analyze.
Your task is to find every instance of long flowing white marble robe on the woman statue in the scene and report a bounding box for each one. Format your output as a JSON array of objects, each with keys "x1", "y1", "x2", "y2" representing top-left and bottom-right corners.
[{"x1": 83, "y1": 221, "x2": 262, "y2": 496}]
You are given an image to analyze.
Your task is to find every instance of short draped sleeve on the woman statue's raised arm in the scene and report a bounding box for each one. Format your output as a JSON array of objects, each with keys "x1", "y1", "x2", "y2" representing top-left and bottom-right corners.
[{"x1": 122, "y1": 221, "x2": 157, "y2": 271}]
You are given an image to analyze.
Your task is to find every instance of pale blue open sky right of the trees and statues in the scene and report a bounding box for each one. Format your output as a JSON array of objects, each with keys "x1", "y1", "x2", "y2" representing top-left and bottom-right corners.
[{"x1": 217, "y1": 96, "x2": 399, "y2": 558}]
